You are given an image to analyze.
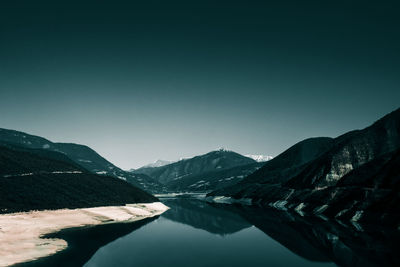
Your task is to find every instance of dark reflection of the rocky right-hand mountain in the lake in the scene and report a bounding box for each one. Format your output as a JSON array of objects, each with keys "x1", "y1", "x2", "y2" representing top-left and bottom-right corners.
[{"x1": 229, "y1": 207, "x2": 400, "y2": 267}]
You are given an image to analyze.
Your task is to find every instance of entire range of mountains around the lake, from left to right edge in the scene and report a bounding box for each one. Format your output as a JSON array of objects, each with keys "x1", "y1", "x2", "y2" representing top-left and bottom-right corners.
[{"x1": 0, "y1": 109, "x2": 400, "y2": 225}]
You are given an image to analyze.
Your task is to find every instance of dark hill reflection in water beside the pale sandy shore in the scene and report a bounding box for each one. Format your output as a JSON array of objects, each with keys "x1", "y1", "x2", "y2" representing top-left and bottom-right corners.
[{"x1": 18, "y1": 216, "x2": 158, "y2": 267}]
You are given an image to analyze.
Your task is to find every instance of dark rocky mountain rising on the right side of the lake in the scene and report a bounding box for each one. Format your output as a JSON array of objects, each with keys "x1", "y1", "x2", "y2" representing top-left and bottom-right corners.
[{"x1": 209, "y1": 109, "x2": 400, "y2": 224}]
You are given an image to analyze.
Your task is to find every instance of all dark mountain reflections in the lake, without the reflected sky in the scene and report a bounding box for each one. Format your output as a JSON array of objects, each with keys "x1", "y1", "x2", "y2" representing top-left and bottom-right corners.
[{"x1": 22, "y1": 199, "x2": 400, "y2": 267}]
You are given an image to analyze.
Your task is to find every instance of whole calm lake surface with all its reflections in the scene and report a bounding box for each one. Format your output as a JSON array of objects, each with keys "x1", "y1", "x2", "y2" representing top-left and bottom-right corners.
[{"x1": 21, "y1": 199, "x2": 400, "y2": 267}]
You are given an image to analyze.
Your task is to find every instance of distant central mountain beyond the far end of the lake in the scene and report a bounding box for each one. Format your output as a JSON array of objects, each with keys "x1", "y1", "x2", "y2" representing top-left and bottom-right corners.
[{"x1": 133, "y1": 149, "x2": 260, "y2": 191}]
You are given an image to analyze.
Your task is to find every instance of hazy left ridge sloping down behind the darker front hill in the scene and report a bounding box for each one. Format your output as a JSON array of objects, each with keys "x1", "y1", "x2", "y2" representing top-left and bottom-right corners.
[{"x1": 0, "y1": 128, "x2": 163, "y2": 192}]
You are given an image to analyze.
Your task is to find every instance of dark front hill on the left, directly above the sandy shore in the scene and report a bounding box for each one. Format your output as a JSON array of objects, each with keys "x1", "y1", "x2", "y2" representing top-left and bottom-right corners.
[{"x1": 0, "y1": 144, "x2": 157, "y2": 213}]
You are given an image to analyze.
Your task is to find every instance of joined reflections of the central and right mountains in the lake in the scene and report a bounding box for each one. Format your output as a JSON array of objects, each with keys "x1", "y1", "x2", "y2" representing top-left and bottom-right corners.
[{"x1": 162, "y1": 199, "x2": 400, "y2": 266}]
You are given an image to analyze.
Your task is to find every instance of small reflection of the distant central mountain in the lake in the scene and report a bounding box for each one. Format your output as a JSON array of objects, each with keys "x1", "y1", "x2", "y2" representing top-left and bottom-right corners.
[{"x1": 162, "y1": 199, "x2": 251, "y2": 235}]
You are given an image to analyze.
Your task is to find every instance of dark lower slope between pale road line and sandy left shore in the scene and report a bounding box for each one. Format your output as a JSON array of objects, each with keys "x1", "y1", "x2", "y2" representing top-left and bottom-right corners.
[{"x1": 0, "y1": 173, "x2": 157, "y2": 213}]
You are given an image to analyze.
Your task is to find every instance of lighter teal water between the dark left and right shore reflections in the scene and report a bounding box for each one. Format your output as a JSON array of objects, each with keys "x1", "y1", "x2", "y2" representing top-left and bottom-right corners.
[{"x1": 85, "y1": 199, "x2": 335, "y2": 267}]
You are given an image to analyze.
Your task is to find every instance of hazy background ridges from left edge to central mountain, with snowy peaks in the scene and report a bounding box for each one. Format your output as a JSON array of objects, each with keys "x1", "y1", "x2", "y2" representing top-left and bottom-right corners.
[{"x1": 0, "y1": 128, "x2": 265, "y2": 193}]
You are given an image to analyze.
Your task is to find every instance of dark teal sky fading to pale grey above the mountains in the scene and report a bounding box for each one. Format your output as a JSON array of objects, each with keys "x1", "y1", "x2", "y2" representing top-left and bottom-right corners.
[{"x1": 0, "y1": 0, "x2": 400, "y2": 169}]
